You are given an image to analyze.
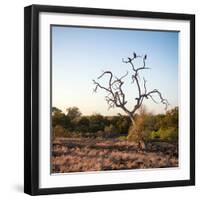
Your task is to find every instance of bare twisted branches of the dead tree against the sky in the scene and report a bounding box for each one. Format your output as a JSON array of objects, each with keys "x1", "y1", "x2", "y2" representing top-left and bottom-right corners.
[{"x1": 93, "y1": 52, "x2": 169, "y2": 124}]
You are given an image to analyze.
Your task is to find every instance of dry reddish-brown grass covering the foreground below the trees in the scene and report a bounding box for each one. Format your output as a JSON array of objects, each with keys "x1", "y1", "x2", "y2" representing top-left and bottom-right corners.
[{"x1": 52, "y1": 138, "x2": 178, "y2": 173}]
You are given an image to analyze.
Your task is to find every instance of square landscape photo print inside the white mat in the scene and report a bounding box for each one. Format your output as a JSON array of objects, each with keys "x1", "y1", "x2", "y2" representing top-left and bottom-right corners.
[{"x1": 50, "y1": 25, "x2": 179, "y2": 174}]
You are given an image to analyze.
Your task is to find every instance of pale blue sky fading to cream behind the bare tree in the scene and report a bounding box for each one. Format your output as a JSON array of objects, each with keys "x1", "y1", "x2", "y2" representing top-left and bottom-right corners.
[{"x1": 52, "y1": 26, "x2": 178, "y2": 115}]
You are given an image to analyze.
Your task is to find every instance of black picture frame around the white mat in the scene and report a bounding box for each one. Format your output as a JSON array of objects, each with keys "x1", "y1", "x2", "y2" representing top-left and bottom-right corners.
[{"x1": 24, "y1": 5, "x2": 195, "y2": 195}]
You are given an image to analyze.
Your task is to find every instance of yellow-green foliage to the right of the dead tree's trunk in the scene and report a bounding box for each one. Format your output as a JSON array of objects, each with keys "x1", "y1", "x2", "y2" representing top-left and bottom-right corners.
[{"x1": 128, "y1": 107, "x2": 178, "y2": 142}]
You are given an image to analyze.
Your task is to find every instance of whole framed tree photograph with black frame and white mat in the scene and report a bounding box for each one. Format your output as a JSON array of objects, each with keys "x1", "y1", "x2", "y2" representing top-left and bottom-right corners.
[{"x1": 24, "y1": 5, "x2": 195, "y2": 195}]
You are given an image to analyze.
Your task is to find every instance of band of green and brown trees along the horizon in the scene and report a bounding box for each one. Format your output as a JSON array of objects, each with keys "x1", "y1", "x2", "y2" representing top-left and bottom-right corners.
[{"x1": 52, "y1": 107, "x2": 178, "y2": 140}]
